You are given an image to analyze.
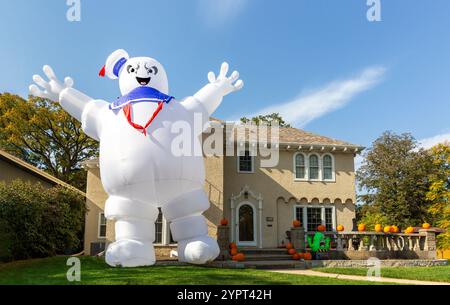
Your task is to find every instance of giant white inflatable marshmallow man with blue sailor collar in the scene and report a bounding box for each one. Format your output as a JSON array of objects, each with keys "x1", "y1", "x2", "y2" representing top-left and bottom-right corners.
[{"x1": 30, "y1": 50, "x2": 244, "y2": 267}]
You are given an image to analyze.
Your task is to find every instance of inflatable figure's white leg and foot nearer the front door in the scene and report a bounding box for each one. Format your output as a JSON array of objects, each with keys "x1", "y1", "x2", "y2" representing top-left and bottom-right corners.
[{"x1": 162, "y1": 189, "x2": 220, "y2": 265}]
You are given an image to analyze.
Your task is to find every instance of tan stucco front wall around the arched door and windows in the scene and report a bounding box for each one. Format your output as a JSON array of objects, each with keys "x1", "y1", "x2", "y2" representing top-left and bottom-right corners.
[{"x1": 224, "y1": 151, "x2": 356, "y2": 247}]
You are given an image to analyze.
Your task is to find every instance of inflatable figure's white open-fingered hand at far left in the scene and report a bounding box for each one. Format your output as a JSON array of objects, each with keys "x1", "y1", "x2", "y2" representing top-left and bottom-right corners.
[{"x1": 29, "y1": 65, "x2": 73, "y2": 102}]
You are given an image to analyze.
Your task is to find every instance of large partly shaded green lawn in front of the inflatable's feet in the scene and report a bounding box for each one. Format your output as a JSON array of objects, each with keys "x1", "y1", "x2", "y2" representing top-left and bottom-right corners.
[{"x1": 0, "y1": 257, "x2": 386, "y2": 285}]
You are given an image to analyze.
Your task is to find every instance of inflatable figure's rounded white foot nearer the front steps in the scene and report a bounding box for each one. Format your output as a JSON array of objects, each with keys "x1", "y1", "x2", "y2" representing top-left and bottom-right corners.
[{"x1": 178, "y1": 236, "x2": 220, "y2": 265}]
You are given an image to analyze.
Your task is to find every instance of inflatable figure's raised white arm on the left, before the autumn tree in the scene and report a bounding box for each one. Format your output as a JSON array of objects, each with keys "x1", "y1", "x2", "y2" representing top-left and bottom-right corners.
[{"x1": 30, "y1": 65, "x2": 107, "y2": 140}]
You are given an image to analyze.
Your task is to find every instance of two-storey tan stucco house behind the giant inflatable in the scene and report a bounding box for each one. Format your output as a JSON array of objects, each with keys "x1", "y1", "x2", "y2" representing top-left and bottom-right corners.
[{"x1": 84, "y1": 121, "x2": 364, "y2": 255}]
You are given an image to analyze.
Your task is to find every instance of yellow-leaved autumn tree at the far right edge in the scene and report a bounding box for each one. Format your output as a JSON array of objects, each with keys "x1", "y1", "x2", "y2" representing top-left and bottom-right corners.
[{"x1": 426, "y1": 143, "x2": 450, "y2": 249}]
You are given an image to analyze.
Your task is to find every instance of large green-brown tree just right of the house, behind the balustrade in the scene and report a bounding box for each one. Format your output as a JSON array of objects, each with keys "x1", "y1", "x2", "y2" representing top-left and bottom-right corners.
[{"x1": 356, "y1": 132, "x2": 434, "y2": 226}]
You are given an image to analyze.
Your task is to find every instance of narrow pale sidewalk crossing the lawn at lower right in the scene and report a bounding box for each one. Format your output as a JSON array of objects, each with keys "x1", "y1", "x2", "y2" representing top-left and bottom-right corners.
[{"x1": 268, "y1": 270, "x2": 450, "y2": 285}]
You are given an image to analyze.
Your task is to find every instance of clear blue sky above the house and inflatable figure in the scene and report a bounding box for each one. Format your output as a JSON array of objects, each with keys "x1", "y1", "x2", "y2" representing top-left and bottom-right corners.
[{"x1": 0, "y1": 0, "x2": 450, "y2": 151}]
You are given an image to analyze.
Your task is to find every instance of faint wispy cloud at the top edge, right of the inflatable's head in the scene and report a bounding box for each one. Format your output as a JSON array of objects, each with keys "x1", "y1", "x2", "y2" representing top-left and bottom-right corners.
[{"x1": 198, "y1": 0, "x2": 248, "y2": 26}]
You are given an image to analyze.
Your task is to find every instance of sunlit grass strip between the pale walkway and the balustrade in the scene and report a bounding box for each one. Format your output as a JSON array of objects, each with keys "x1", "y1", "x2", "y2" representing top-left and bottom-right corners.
[{"x1": 314, "y1": 266, "x2": 450, "y2": 282}]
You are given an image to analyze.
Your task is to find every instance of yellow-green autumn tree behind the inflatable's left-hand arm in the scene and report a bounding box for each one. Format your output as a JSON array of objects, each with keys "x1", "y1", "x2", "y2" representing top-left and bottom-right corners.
[{"x1": 0, "y1": 93, "x2": 98, "y2": 190}]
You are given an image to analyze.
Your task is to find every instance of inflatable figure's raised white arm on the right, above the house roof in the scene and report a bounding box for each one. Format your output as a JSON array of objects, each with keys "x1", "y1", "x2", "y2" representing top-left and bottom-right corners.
[{"x1": 182, "y1": 62, "x2": 244, "y2": 121}]
